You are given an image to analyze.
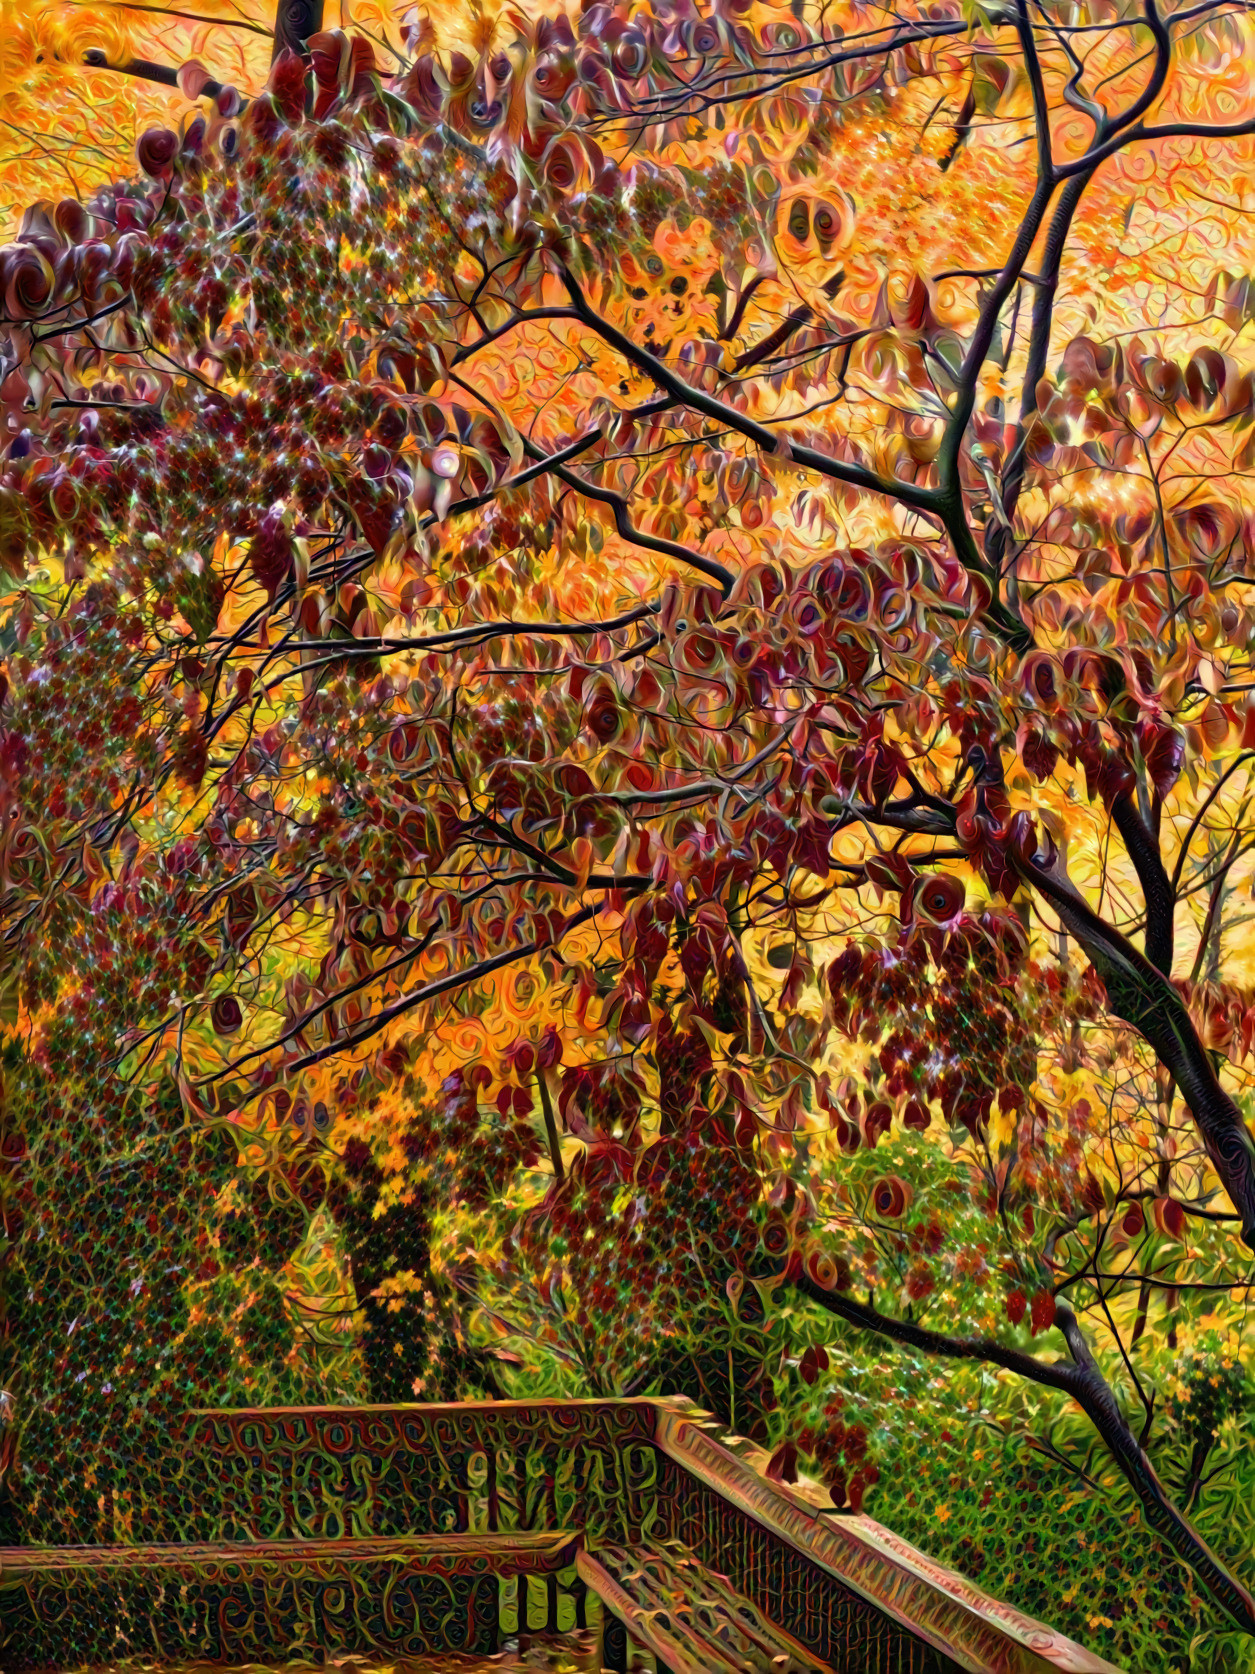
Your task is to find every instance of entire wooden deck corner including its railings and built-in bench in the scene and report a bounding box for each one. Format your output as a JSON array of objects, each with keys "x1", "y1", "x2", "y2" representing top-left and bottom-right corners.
[{"x1": 0, "y1": 1399, "x2": 1119, "y2": 1674}]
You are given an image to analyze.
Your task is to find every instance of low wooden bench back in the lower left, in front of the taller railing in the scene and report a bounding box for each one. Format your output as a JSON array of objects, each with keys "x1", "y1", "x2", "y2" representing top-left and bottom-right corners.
[{"x1": 0, "y1": 1530, "x2": 581, "y2": 1674}]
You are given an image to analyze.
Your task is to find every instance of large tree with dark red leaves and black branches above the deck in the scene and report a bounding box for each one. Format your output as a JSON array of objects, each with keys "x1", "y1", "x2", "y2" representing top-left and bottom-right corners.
[{"x1": 0, "y1": 0, "x2": 1255, "y2": 1632}]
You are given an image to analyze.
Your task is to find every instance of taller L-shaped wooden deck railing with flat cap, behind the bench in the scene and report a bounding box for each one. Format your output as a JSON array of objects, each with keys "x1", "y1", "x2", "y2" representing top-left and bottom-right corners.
[{"x1": 0, "y1": 1399, "x2": 1111, "y2": 1674}]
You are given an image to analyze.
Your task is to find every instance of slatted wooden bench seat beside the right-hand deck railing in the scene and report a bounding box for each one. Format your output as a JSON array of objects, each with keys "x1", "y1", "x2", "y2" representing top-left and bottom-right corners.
[{"x1": 576, "y1": 1542, "x2": 832, "y2": 1674}]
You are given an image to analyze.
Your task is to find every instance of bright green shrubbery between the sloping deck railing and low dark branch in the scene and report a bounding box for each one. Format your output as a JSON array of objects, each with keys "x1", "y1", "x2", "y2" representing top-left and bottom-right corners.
[{"x1": 771, "y1": 1307, "x2": 1255, "y2": 1674}]
